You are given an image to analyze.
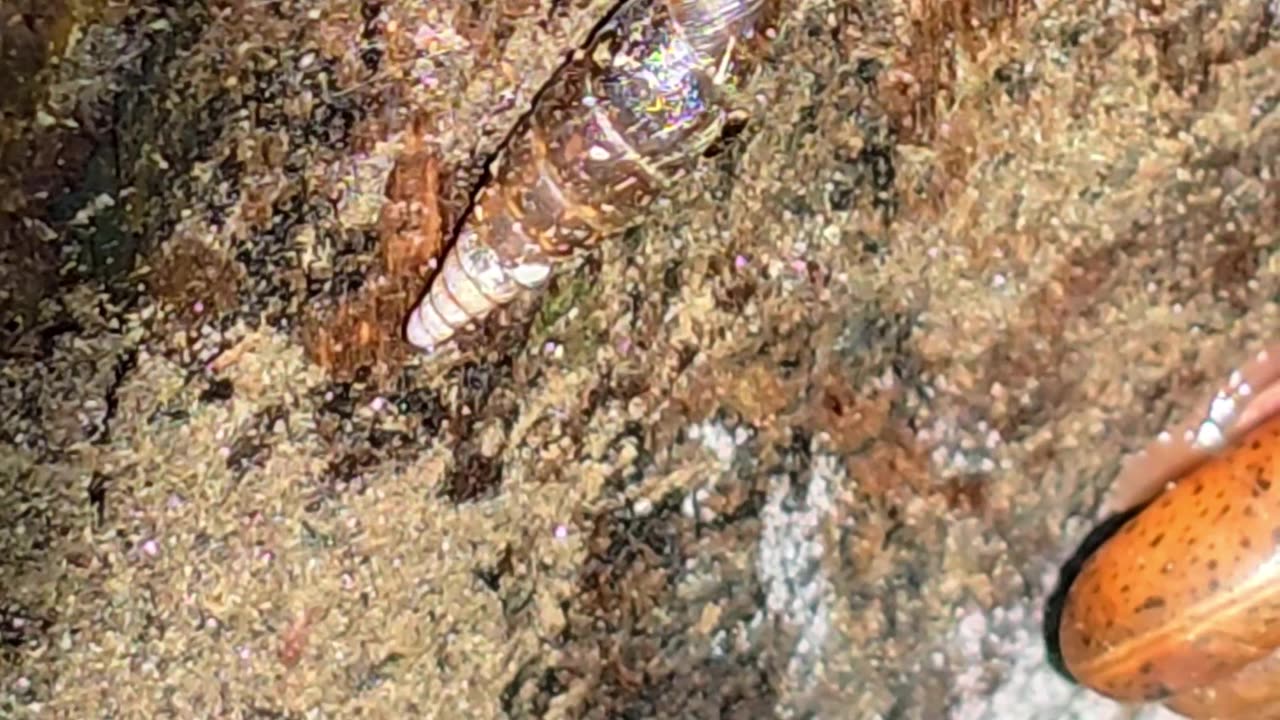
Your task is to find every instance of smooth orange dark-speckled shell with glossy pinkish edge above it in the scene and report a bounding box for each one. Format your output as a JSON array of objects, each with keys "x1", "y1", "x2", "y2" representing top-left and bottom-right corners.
[{"x1": 1059, "y1": 345, "x2": 1280, "y2": 720}]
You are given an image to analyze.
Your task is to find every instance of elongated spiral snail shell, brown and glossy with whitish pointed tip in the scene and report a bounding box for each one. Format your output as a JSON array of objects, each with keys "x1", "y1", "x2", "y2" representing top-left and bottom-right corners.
[{"x1": 406, "y1": 0, "x2": 780, "y2": 350}]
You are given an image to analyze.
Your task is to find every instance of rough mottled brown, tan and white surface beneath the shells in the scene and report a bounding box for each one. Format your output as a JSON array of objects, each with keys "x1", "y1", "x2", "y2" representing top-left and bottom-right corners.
[{"x1": 0, "y1": 0, "x2": 1280, "y2": 719}]
